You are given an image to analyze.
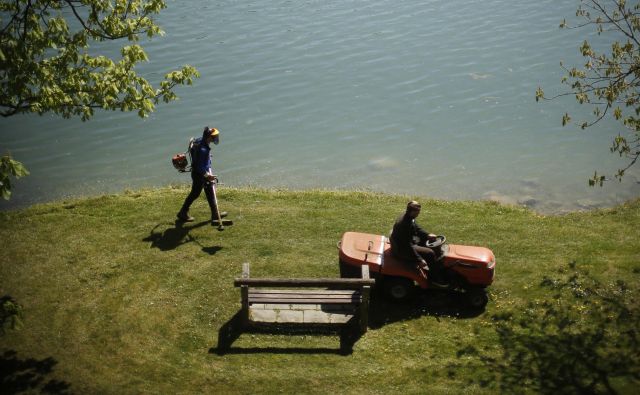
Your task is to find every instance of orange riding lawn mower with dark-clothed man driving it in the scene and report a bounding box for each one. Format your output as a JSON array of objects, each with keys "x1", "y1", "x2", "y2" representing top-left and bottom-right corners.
[{"x1": 339, "y1": 202, "x2": 496, "y2": 309}]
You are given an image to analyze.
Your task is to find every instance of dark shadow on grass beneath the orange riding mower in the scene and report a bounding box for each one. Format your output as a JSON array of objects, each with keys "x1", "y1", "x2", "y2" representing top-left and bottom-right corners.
[{"x1": 369, "y1": 290, "x2": 484, "y2": 329}]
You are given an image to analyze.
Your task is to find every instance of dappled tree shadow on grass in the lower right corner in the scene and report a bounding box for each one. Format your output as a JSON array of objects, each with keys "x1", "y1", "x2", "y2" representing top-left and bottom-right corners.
[{"x1": 447, "y1": 264, "x2": 640, "y2": 394}]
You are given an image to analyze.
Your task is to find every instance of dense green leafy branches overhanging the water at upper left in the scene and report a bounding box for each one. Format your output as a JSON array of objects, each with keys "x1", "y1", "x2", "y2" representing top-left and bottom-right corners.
[{"x1": 0, "y1": 0, "x2": 198, "y2": 120}]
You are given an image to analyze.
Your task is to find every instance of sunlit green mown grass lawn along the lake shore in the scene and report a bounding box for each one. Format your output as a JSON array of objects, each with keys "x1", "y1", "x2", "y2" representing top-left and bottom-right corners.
[{"x1": 0, "y1": 188, "x2": 640, "y2": 394}]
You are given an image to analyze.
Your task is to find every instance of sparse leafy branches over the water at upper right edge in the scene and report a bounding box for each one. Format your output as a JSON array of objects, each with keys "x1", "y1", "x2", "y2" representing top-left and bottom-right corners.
[{"x1": 536, "y1": 0, "x2": 640, "y2": 186}]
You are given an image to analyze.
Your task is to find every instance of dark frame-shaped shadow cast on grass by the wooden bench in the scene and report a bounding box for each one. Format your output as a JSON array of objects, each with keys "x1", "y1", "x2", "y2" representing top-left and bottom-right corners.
[{"x1": 209, "y1": 311, "x2": 360, "y2": 356}]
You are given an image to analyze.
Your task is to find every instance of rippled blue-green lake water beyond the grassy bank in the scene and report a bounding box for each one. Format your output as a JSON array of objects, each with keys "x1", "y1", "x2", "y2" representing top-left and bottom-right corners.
[{"x1": 0, "y1": 0, "x2": 640, "y2": 213}]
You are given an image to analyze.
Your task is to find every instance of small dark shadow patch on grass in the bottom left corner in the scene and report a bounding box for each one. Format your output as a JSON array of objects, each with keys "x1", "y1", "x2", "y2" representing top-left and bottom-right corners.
[{"x1": 0, "y1": 350, "x2": 71, "y2": 394}]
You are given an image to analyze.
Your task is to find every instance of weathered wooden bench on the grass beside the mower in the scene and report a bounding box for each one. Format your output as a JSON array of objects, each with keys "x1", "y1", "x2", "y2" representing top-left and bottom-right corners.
[{"x1": 234, "y1": 263, "x2": 375, "y2": 337}]
